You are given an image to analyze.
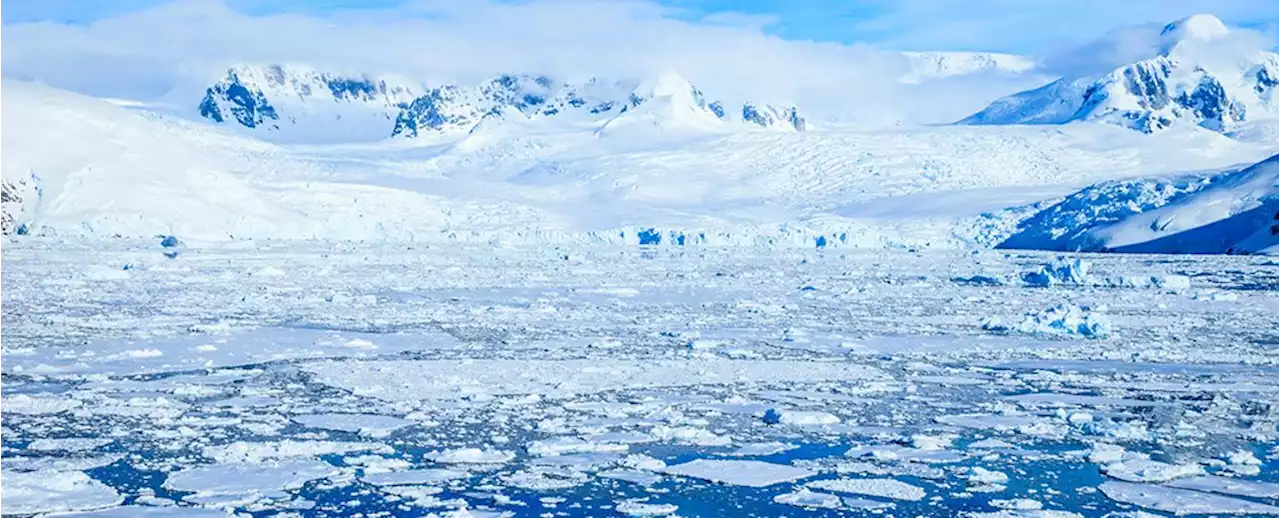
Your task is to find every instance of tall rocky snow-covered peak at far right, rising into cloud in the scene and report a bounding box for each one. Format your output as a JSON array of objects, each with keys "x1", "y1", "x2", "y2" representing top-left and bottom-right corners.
[{"x1": 960, "y1": 14, "x2": 1280, "y2": 133}]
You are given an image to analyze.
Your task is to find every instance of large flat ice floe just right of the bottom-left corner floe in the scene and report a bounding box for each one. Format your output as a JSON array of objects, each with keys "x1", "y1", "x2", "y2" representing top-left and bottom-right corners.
[{"x1": 164, "y1": 459, "x2": 342, "y2": 499}]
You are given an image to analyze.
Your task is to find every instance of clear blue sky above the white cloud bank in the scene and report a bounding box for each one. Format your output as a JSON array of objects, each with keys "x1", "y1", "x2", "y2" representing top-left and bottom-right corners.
[{"x1": 0, "y1": 0, "x2": 1280, "y2": 52}]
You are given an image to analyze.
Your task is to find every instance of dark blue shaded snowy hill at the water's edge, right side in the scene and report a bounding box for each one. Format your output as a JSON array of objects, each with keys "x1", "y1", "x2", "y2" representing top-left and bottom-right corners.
[{"x1": 1001, "y1": 156, "x2": 1280, "y2": 253}]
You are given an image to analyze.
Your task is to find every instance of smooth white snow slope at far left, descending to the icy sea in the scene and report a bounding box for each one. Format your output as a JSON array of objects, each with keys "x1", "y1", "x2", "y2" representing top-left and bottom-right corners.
[{"x1": 0, "y1": 82, "x2": 554, "y2": 239}]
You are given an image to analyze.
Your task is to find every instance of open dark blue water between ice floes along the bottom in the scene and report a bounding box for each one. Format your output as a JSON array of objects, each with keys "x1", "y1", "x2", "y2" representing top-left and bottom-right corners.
[{"x1": 27, "y1": 434, "x2": 1280, "y2": 517}]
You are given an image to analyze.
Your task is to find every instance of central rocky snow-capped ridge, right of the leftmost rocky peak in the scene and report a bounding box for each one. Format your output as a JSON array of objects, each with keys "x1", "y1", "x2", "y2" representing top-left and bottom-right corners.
[{"x1": 392, "y1": 73, "x2": 808, "y2": 138}]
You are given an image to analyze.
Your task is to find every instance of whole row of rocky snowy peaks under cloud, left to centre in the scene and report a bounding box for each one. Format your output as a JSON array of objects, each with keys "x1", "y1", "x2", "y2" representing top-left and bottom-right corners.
[{"x1": 200, "y1": 65, "x2": 806, "y2": 143}]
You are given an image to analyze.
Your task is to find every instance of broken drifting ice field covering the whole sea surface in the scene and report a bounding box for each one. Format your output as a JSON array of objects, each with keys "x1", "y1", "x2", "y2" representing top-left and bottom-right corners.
[{"x1": 0, "y1": 239, "x2": 1280, "y2": 517}]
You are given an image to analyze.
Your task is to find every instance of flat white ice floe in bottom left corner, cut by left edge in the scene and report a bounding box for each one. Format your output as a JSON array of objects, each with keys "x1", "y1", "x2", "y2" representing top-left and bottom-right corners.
[{"x1": 0, "y1": 471, "x2": 124, "y2": 515}]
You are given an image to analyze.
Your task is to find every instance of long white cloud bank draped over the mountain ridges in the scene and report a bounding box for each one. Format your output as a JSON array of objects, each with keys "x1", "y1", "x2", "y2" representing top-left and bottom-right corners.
[{"x1": 0, "y1": 0, "x2": 1059, "y2": 122}]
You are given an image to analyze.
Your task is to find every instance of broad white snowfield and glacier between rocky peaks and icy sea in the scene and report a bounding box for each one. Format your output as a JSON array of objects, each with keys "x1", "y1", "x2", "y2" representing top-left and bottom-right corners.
[{"x1": 0, "y1": 75, "x2": 1267, "y2": 254}]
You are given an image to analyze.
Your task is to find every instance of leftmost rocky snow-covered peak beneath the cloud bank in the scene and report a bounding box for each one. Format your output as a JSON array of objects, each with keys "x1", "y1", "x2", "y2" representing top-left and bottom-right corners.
[{"x1": 200, "y1": 65, "x2": 424, "y2": 142}]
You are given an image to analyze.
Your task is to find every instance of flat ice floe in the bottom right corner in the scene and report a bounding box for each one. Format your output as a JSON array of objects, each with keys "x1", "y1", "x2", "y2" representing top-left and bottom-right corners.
[{"x1": 1098, "y1": 481, "x2": 1280, "y2": 514}]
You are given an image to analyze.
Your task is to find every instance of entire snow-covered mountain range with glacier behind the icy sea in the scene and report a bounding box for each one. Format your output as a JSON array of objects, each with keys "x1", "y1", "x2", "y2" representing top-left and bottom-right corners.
[{"x1": 0, "y1": 15, "x2": 1280, "y2": 253}]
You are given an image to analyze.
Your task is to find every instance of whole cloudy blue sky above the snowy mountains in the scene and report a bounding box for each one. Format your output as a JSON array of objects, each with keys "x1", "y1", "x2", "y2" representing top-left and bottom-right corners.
[{"x1": 0, "y1": 0, "x2": 1280, "y2": 123}]
